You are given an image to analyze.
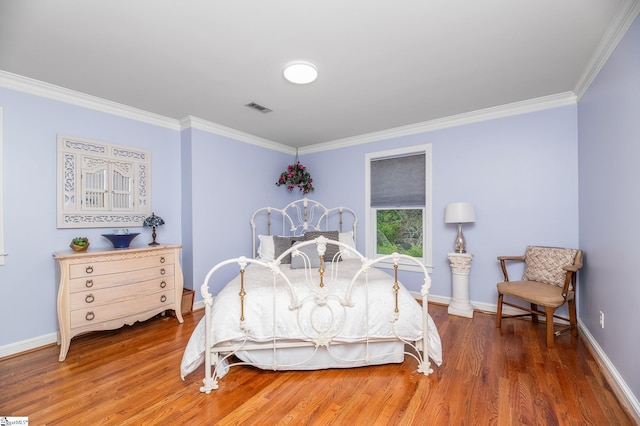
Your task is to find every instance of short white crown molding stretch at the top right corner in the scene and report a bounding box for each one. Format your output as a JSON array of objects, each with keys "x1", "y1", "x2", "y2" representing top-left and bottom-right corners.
[{"x1": 573, "y1": 0, "x2": 640, "y2": 100}]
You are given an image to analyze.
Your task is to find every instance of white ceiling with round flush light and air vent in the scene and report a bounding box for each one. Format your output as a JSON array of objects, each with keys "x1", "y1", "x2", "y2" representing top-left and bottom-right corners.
[{"x1": 0, "y1": 0, "x2": 638, "y2": 147}]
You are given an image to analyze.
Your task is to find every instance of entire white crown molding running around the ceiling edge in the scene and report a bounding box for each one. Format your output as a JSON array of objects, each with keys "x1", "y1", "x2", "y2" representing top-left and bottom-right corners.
[{"x1": 0, "y1": 0, "x2": 640, "y2": 154}]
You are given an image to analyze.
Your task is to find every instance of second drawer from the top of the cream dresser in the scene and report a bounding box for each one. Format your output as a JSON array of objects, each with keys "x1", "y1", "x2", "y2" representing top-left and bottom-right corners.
[{"x1": 69, "y1": 265, "x2": 175, "y2": 293}]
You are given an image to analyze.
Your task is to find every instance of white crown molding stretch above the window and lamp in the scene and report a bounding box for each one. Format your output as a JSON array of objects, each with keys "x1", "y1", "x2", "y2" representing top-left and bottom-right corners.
[{"x1": 299, "y1": 92, "x2": 577, "y2": 154}]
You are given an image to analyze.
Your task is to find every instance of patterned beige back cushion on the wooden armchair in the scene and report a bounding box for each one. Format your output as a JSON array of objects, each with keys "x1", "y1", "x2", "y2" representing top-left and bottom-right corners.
[{"x1": 522, "y1": 246, "x2": 578, "y2": 287}]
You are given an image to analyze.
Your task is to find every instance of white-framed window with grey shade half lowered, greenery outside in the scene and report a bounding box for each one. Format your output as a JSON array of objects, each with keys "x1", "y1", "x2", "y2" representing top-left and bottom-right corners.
[{"x1": 365, "y1": 145, "x2": 432, "y2": 270}]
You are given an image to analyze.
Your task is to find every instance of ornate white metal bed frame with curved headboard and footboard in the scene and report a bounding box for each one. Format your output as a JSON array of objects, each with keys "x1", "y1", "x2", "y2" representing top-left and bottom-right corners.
[{"x1": 200, "y1": 198, "x2": 433, "y2": 394}]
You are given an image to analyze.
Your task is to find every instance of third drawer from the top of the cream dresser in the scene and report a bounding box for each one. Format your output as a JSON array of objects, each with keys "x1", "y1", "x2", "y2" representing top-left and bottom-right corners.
[{"x1": 70, "y1": 279, "x2": 174, "y2": 311}]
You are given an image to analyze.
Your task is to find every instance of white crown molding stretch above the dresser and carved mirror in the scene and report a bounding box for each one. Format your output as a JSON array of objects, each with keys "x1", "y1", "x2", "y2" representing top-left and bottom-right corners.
[{"x1": 0, "y1": 70, "x2": 180, "y2": 130}]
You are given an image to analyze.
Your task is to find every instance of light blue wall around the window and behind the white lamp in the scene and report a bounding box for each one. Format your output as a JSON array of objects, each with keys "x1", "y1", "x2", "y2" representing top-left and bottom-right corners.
[{"x1": 305, "y1": 106, "x2": 578, "y2": 305}]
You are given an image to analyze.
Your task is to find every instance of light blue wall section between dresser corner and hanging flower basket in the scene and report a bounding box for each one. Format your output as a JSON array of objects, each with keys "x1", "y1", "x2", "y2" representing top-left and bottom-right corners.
[{"x1": 183, "y1": 129, "x2": 295, "y2": 300}]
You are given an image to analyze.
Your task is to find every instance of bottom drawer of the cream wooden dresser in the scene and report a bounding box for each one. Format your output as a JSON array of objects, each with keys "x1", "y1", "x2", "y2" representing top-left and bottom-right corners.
[{"x1": 71, "y1": 290, "x2": 174, "y2": 330}]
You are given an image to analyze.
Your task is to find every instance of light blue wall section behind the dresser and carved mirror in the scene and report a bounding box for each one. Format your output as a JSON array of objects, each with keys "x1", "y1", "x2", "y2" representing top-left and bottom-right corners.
[{"x1": 0, "y1": 88, "x2": 182, "y2": 346}]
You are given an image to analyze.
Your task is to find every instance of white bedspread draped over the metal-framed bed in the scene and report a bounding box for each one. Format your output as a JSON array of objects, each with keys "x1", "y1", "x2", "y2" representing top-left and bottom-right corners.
[{"x1": 180, "y1": 259, "x2": 442, "y2": 378}]
